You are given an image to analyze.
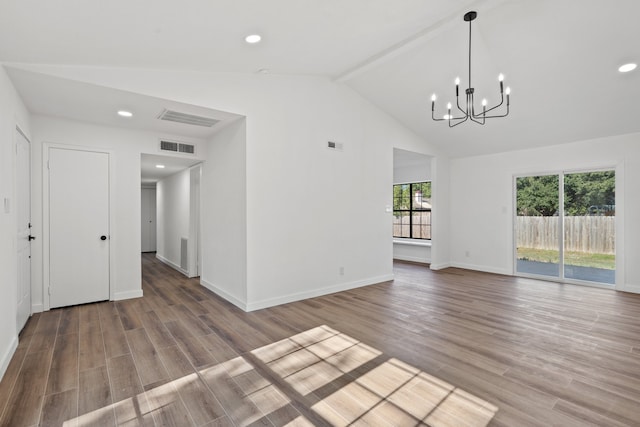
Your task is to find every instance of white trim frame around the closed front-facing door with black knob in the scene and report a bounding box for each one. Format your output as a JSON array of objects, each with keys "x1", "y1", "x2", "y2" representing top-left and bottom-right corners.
[{"x1": 42, "y1": 142, "x2": 118, "y2": 311}]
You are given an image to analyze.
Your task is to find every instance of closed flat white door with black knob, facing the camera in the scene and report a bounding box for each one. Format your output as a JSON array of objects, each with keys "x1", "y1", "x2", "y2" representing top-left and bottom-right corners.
[{"x1": 49, "y1": 147, "x2": 110, "y2": 308}]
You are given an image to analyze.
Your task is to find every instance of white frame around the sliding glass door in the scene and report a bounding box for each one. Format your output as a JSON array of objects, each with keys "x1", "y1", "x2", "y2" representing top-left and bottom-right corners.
[{"x1": 511, "y1": 161, "x2": 626, "y2": 291}]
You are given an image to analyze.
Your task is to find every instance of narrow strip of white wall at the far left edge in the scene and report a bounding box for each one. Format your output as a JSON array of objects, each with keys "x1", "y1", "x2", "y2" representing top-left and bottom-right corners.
[{"x1": 0, "y1": 67, "x2": 31, "y2": 378}]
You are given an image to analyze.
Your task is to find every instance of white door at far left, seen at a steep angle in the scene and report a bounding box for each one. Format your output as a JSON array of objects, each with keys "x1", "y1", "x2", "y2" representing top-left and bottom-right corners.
[{"x1": 16, "y1": 129, "x2": 31, "y2": 332}]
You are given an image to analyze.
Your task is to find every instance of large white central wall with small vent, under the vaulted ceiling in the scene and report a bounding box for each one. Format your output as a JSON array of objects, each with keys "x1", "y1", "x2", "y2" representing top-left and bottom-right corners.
[{"x1": 12, "y1": 66, "x2": 448, "y2": 309}]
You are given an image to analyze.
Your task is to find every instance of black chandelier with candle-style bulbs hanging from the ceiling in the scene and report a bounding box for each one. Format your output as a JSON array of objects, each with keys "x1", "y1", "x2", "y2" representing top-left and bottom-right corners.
[{"x1": 431, "y1": 11, "x2": 511, "y2": 127}]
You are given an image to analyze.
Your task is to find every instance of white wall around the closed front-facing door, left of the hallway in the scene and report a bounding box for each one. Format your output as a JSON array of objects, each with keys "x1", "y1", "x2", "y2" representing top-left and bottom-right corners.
[{"x1": 31, "y1": 115, "x2": 206, "y2": 311}]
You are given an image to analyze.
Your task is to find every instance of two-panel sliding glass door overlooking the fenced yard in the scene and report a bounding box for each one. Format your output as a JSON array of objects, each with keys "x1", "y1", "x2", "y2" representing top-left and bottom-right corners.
[{"x1": 515, "y1": 170, "x2": 615, "y2": 285}]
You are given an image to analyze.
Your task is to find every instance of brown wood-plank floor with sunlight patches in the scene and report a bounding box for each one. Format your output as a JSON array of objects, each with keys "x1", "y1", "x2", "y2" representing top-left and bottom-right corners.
[{"x1": 0, "y1": 255, "x2": 640, "y2": 426}]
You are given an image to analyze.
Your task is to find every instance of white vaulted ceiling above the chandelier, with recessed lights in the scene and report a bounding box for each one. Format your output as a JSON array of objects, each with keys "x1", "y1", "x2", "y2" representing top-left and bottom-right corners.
[{"x1": 0, "y1": 0, "x2": 640, "y2": 156}]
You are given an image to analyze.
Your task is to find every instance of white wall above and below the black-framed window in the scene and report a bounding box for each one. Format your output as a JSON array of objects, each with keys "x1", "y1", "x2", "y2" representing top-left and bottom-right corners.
[{"x1": 393, "y1": 150, "x2": 433, "y2": 263}]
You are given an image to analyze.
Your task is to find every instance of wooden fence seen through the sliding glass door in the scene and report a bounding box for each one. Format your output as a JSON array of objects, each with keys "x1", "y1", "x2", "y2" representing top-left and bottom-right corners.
[{"x1": 516, "y1": 216, "x2": 616, "y2": 254}]
